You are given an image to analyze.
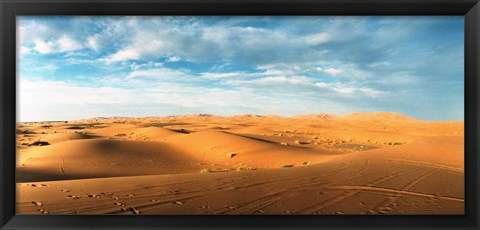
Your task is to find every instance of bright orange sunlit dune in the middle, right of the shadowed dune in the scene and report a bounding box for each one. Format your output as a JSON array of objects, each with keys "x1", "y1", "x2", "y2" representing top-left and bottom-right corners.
[{"x1": 168, "y1": 131, "x2": 332, "y2": 169}]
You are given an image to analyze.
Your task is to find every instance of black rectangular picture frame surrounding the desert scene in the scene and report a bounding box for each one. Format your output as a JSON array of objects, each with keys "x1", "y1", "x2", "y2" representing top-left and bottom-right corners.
[{"x1": 0, "y1": 0, "x2": 480, "y2": 229}]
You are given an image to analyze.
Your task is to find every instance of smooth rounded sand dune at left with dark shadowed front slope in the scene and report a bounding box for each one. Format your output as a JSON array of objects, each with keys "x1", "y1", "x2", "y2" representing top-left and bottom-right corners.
[{"x1": 17, "y1": 140, "x2": 201, "y2": 181}]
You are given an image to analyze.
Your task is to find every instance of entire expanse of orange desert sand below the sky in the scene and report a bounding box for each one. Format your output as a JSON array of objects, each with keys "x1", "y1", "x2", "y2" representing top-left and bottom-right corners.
[{"x1": 16, "y1": 112, "x2": 464, "y2": 215}]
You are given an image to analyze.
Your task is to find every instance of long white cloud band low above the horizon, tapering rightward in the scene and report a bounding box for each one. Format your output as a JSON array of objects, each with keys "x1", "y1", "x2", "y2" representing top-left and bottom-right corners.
[{"x1": 18, "y1": 78, "x2": 299, "y2": 121}]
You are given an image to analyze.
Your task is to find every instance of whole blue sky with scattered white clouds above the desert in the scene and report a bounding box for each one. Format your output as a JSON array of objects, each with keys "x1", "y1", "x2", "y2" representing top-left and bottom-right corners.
[{"x1": 17, "y1": 16, "x2": 464, "y2": 121}]
